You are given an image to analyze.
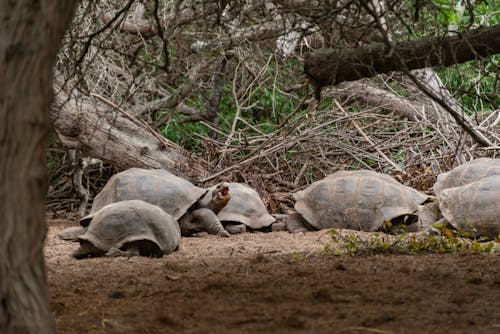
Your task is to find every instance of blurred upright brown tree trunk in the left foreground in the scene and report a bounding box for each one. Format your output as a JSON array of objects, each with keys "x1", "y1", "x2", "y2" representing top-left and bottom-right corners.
[{"x1": 0, "y1": 0, "x2": 77, "y2": 334}]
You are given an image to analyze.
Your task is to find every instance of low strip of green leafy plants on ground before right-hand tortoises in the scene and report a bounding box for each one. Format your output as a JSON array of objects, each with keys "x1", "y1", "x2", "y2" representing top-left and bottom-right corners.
[{"x1": 323, "y1": 230, "x2": 499, "y2": 256}]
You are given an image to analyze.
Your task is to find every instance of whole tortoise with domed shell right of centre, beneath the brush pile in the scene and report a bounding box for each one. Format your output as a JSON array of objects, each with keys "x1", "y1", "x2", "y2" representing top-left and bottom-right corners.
[{"x1": 287, "y1": 170, "x2": 428, "y2": 232}]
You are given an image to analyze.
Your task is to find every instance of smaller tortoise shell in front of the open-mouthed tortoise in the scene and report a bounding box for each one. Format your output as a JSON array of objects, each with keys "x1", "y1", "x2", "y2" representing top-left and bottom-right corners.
[{"x1": 78, "y1": 200, "x2": 181, "y2": 256}]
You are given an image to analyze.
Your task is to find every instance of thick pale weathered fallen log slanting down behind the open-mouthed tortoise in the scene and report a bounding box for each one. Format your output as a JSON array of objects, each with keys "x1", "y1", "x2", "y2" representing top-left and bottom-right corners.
[{"x1": 51, "y1": 77, "x2": 207, "y2": 179}]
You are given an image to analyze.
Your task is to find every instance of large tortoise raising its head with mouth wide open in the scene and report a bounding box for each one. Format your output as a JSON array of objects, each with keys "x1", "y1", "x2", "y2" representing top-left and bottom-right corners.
[{"x1": 59, "y1": 168, "x2": 231, "y2": 240}]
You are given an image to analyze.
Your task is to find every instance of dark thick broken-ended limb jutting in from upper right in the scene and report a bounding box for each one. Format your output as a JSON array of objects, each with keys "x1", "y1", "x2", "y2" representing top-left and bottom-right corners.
[{"x1": 304, "y1": 25, "x2": 500, "y2": 89}]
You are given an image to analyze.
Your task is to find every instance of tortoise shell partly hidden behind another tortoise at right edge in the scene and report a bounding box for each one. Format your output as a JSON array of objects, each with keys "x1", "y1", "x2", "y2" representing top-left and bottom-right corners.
[{"x1": 433, "y1": 158, "x2": 500, "y2": 196}]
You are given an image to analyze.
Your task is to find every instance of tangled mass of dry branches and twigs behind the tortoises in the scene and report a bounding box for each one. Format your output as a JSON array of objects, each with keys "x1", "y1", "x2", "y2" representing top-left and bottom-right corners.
[{"x1": 53, "y1": 0, "x2": 500, "y2": 211}]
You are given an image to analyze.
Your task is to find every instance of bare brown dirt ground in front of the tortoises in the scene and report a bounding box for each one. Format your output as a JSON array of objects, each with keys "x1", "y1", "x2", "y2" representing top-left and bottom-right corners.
[{"x1": 46, "y1": 220, "x2": 500, "y2": 333}]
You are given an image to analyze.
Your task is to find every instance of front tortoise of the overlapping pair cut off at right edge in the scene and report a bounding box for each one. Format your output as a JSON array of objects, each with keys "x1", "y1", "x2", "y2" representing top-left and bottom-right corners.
[{"x1": 420, "y1": 175, "x2": 500, "y2": 239}]
